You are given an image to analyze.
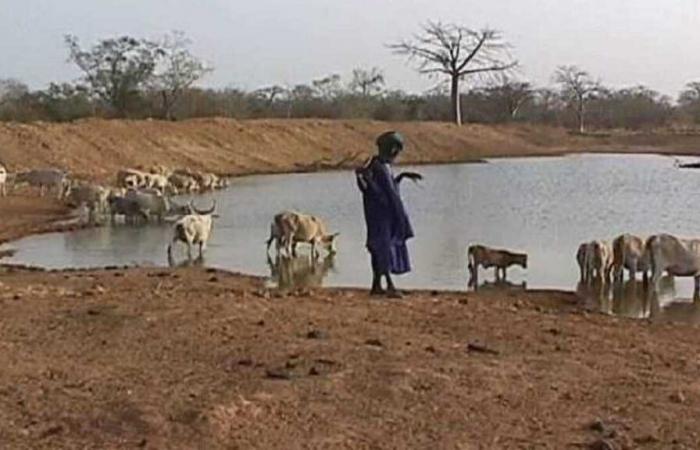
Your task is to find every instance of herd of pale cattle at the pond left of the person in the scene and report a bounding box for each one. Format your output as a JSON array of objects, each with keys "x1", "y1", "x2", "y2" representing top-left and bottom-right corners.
[{"x1": 0, "y1": 164, "x2": 338, "y2": 261}]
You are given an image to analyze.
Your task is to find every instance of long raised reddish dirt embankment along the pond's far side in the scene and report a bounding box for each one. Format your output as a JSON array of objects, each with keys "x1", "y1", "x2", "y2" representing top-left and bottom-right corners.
[{"x1": 0, "y1": 119, "x2": 700, "y2": 185}]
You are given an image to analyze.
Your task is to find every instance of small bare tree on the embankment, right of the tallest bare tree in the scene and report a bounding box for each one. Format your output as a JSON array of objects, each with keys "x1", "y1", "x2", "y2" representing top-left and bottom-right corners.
[{"x1": 554, "y1": 66, "x2": 603, "y2": 133}]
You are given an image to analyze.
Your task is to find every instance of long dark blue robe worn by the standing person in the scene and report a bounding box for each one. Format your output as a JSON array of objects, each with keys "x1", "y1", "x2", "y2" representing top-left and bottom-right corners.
[{"x1": 356, "y1": 157, "x2": 413, "y2": 274}]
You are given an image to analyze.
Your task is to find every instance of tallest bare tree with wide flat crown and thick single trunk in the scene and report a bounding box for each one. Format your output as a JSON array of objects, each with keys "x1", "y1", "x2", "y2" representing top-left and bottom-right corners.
[{"x1": 389, "y1": 22, "x2": 518, "y2": 125}]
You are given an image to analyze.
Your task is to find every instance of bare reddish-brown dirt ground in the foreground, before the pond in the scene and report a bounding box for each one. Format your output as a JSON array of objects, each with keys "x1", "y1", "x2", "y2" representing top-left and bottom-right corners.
[{"x1": 0, "y1": 269, "x2": 700, "y2": 449}]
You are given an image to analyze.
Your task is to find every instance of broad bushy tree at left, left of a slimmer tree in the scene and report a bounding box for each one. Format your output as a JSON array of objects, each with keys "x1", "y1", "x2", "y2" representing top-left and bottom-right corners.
[{"x1": 65, "y1": 35, "x2": 163, "y2": 116}]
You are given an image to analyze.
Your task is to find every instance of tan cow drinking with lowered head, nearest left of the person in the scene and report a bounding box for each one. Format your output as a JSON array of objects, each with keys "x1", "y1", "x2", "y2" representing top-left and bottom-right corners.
[{"x1": 266, "y1": 211, "x2": 340, "y2": 259}]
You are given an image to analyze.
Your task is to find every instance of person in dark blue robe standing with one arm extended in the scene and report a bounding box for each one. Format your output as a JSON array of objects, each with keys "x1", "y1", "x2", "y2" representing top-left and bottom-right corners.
[{"x1": 355, "y1": 131, "x2": 423, "y2": 298}]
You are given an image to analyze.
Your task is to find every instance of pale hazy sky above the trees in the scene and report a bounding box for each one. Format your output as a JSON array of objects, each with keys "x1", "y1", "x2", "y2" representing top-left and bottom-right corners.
[{"x1": 0, "y1": 0, "x2": 700, "y2": 97}]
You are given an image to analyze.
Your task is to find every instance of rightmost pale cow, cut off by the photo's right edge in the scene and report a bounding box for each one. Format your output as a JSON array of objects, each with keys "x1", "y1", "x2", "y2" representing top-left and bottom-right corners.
[{"x1": 645, "y1": 234, "x2": 700, "y2": 300}]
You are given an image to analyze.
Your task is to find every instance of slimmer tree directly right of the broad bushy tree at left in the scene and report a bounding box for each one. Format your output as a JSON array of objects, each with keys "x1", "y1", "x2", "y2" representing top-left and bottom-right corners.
[{"x1": 150, "y1": 31, "x2": 214, "y2": 120}]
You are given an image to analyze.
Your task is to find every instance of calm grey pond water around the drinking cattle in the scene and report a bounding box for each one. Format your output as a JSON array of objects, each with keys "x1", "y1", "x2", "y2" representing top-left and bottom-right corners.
[{"x1": 6, "y1": 154, "x2": 700, "y2": 324}]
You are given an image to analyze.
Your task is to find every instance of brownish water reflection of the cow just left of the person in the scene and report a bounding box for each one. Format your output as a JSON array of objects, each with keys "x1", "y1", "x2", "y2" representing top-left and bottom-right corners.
[{"x1": 267, "y1": 254, "x2": 335, "y2": 290}]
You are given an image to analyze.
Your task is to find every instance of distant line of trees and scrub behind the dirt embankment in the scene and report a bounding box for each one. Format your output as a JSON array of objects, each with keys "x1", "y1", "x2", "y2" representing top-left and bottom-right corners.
[{"x1": 0, "y1": 34, "x2": 700, "y2": 129}]
